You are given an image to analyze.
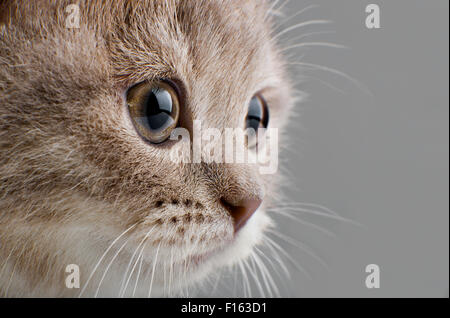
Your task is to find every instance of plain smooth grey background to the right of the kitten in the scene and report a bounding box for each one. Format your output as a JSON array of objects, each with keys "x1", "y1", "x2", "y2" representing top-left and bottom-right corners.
[{"x1": 272, "y1": 0, "x2": 449, "y2": 297}]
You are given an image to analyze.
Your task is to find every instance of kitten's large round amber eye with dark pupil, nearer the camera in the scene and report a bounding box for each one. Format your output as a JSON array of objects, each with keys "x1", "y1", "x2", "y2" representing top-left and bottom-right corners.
[{"x1": 127, "y1": 81, "x2": 180, "y2": 144}]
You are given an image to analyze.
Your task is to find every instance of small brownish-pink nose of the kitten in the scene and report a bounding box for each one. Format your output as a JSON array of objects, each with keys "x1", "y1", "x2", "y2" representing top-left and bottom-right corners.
[{"x1": 220, "y1": 197, "x2": 262, "y2": 233}]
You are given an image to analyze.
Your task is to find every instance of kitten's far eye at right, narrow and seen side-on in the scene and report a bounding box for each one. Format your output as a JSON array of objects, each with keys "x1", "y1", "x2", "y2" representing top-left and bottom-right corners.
[{"x1": 245, "y1": 94, "x2": 269, "y2": 148}]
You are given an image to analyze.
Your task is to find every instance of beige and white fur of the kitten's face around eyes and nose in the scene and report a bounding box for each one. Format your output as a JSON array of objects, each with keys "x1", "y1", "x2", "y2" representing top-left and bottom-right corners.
[{"x1": 0, "y1": 0, "x2": 292, "y2": 296}]
